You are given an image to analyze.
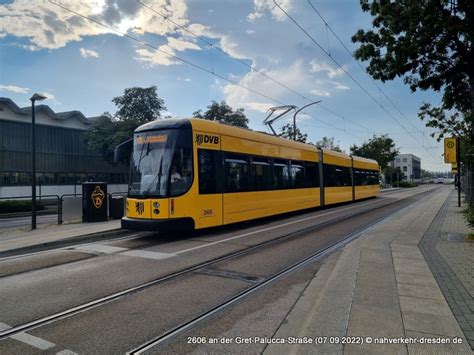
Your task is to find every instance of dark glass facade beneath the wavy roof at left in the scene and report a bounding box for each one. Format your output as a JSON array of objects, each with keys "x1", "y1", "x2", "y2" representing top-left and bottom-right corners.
[{"x1": 0, "y1": 120, "x2": 128, "y2": 186}]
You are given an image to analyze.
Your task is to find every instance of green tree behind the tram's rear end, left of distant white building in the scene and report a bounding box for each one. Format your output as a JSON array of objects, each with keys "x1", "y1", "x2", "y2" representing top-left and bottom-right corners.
[{"x1": 351, "y1": 134, "x2": 399, "y2": 170}]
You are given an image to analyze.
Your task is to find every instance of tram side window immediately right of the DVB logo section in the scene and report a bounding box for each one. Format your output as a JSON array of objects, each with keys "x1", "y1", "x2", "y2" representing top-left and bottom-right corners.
[{"x1": 225, "y1": 154, "x2": 250, "y2": 192}]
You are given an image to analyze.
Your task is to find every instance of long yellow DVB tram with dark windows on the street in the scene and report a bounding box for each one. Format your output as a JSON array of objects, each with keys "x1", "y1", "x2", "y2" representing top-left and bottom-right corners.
[{"x1": 122, "y1": 119, "x2": 380, "y2": 230}]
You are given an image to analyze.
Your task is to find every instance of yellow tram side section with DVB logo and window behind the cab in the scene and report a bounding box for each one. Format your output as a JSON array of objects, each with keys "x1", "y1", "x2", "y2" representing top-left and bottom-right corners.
[{"x1": 194, "y1": 133, "x2": 223, "y2": 228}]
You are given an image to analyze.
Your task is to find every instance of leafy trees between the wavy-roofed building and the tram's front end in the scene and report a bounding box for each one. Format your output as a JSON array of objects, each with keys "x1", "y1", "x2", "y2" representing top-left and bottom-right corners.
[{"x1": 84, "y1": 86, "x2": 166, "y2": 164}]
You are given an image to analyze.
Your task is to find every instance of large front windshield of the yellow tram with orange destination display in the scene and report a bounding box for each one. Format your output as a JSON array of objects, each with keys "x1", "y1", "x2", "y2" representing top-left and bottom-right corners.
[{"x1": 129, "y1": 129, "x2": 193, "y2": 197}]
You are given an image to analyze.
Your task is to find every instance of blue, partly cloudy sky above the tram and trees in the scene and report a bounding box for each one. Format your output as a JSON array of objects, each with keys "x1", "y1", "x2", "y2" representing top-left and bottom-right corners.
[{"x1": 0, "y1": 0, "x2": 450, "y2": 171}]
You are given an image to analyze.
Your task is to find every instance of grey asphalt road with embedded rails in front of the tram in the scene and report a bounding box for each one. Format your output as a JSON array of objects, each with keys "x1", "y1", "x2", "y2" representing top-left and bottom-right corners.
[{"x1": 0, "y1": 187, "x2": 437, "y2": 354}]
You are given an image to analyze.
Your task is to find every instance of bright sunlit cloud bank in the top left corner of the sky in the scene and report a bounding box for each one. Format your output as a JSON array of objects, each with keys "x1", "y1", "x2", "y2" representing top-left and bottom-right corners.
[{"x1": 0, "y1": 0, "x2": 193, "y2": 50}]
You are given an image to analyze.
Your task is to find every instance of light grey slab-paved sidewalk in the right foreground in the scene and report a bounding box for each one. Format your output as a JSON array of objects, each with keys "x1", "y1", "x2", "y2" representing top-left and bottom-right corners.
[{"x1": 265, "y1": 188, "x2": 472, "y2": 354}]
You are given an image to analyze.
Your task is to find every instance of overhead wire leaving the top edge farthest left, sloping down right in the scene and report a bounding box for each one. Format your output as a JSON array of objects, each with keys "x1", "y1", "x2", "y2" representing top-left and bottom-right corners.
[{"x1": 49, "y1": 0, "x2": 362, "y2": 144}]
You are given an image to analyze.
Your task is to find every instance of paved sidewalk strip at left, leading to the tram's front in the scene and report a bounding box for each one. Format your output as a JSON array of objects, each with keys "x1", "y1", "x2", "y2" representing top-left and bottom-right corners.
[{"x1": 0, "y1": 219, "x2": 122, "y2": 257}]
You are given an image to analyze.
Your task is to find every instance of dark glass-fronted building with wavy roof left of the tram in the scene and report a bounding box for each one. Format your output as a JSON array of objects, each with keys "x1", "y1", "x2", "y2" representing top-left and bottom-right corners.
[{"x1": 0, "y1": 97, "x2": 128, "y2": 197}]
